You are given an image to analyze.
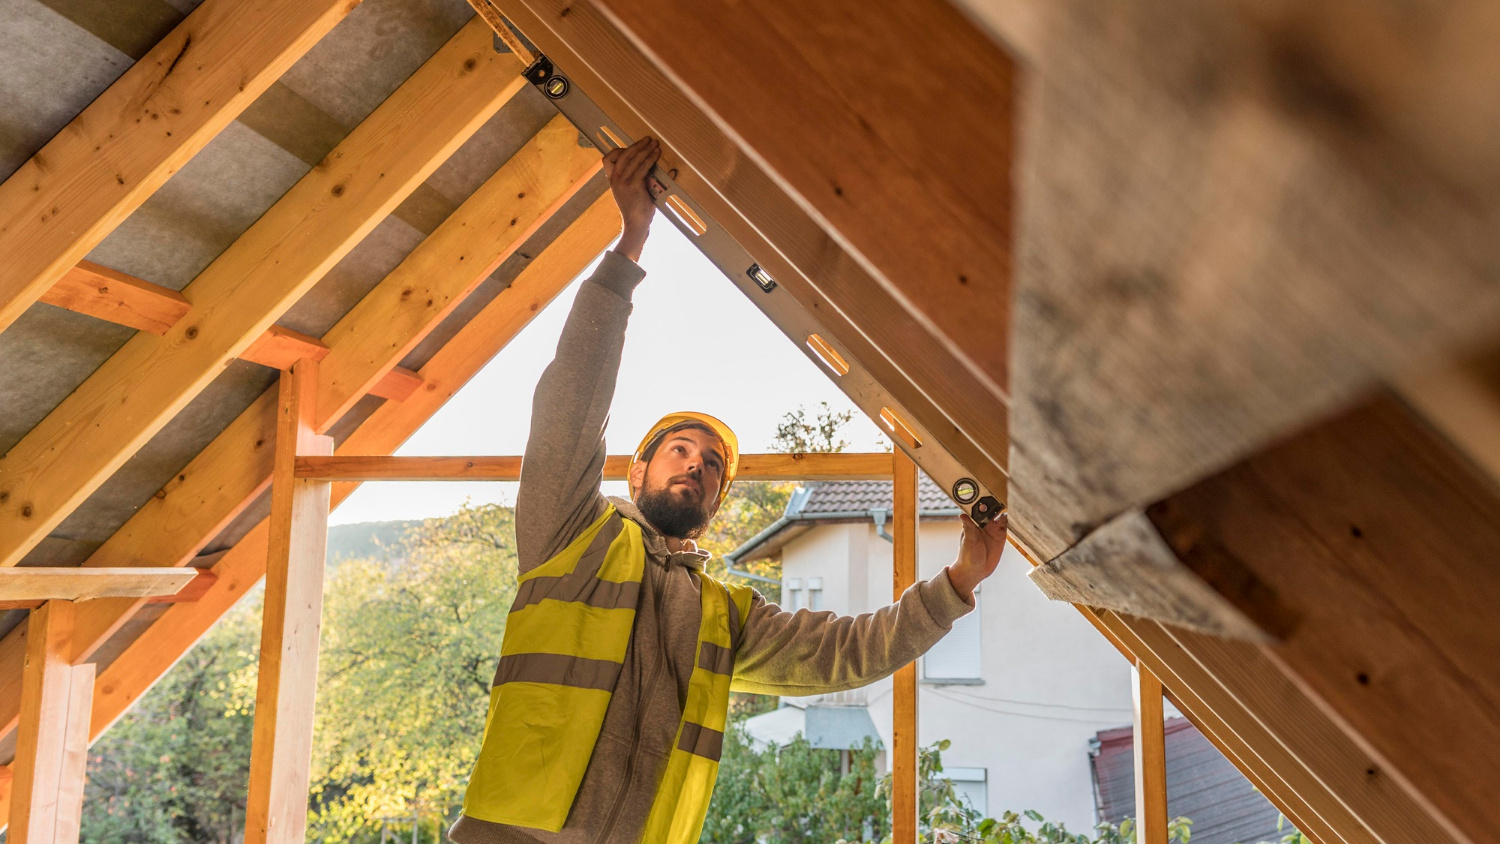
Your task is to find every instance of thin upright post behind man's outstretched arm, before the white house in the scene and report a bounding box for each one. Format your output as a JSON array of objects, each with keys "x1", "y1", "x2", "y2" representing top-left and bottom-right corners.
[{"x1": 891, "y1": 448, "x2": 918, "y2": 844}]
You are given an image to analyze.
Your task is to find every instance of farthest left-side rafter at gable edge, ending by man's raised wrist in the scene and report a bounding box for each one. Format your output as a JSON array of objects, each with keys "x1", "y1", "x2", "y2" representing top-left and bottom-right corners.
[{"x1": 77, "y1": 193, "x2": 620, "y2": 773}]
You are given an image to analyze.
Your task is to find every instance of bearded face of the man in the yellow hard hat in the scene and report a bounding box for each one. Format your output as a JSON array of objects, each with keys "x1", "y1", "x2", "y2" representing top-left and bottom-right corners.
[{"x1": 630, "y1": 427, "x2": 725, "y2": 538}]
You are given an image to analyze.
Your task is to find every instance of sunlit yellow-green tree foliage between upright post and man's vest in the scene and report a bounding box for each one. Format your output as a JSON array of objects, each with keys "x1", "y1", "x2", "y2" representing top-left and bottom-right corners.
[{"x1": 311, "y1": 505, "x2": 518, "y2": 844}]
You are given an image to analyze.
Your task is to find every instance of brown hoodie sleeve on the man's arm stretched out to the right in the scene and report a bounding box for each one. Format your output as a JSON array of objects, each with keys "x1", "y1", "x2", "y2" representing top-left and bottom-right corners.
[{"x1": 734, "y1": 568, "x2": 974, "y2": 696}]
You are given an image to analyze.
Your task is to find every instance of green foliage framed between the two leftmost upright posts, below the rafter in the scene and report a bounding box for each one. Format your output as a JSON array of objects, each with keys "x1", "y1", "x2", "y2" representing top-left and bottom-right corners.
[{"x1": 81, "y1": 601, "x2": 261, "y2": 844}]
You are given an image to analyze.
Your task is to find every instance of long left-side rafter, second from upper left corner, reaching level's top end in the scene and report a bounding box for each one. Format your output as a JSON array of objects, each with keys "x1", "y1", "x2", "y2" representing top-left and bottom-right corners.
[{"x1": 0, "y1": 21, "x2": 524, "y2": 565}]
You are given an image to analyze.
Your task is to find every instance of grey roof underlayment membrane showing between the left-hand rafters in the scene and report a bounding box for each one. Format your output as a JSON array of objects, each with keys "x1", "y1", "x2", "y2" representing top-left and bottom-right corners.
[{"x1": 0, "y1": 0, "x2": 605, "y2": 668}]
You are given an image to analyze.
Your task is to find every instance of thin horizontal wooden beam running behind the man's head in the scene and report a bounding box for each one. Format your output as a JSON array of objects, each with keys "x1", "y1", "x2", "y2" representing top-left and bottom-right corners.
[{"x1": 297, "y1": 453, "x2": 891, "y2": 483}]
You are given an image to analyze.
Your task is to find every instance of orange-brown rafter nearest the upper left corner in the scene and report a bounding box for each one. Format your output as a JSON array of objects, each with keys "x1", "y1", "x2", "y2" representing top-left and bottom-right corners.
[{"x1": 0, "y1": 0, "x2": 356, "y2": 337}]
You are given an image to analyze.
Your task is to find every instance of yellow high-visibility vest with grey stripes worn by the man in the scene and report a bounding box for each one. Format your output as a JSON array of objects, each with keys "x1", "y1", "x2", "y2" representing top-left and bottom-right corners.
[{"x1": 464, "y1": 507, "x2": 753, "y2": 844}]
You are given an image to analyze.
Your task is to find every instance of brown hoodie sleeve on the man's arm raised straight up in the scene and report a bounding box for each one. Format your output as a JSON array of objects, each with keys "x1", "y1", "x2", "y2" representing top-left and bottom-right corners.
[{"x1": 516, "y1": 252, "x2": 645, "y2": 574}]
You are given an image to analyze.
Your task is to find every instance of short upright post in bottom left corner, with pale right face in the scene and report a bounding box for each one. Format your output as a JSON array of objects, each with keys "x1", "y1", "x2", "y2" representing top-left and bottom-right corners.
[{"x1": 6, "y1": 601, "x2": 95, "y2": 844}]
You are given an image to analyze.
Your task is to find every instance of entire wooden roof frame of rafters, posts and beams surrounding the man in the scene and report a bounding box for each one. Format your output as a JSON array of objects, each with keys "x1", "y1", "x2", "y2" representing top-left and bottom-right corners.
[{"x1": 0, "y1": 0, "x2": 1500, "y2": 844}]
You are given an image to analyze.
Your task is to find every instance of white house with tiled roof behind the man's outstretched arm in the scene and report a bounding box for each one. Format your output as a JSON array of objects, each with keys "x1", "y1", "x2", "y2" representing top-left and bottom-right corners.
[{"x1": 729, "y1": 477, "x2": 1131, "y2": 832}]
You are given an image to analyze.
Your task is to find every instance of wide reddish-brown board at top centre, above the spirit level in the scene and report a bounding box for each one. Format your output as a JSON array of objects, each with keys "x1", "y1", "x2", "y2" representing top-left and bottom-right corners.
[{"x1": 594, "y1": 0, "x2": 1016, "y2": 396}]
